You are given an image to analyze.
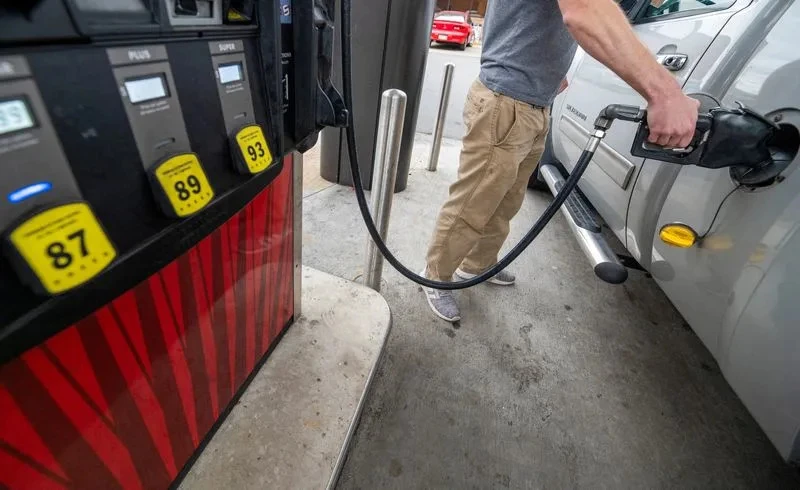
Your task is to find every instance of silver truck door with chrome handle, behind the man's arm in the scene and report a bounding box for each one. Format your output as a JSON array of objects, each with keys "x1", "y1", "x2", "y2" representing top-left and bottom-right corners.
[{"x1": 553, "y1": 0, "x2": 751, "y2": 245}]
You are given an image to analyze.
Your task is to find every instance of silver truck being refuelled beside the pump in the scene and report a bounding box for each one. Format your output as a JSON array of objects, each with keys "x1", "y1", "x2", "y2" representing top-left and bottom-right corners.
[{"x1": 531, "y1": 0, "x2": 800, "y2": 464}]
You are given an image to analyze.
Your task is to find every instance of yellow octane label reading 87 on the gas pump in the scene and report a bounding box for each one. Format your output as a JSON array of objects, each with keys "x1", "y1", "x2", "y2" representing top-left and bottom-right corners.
[{"x1": 10, "y1": 202, "x2": 117, "y2": 294}]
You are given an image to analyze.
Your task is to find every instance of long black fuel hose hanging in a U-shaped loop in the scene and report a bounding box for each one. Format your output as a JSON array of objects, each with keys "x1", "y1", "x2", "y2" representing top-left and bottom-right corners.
[{"x1": 341, "y1": 0, "x2": 594, "y2": 290}]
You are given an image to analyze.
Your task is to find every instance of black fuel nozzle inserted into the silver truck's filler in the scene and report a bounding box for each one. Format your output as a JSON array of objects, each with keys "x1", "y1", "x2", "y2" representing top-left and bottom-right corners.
[{"x1": 595, "y1": 104, "x2": 779, "y2": 168}]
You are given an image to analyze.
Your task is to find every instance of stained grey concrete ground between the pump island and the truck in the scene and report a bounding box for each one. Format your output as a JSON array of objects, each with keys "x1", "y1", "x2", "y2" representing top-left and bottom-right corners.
[{"x1": 303, "y1": 135, "x2": 800, "y2": 489}]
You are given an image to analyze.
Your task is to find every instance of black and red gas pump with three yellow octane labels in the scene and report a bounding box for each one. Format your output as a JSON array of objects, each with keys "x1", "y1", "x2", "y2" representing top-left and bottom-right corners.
[{"x1": 0, "y1": 0, "x2": 332, "y2": 489}]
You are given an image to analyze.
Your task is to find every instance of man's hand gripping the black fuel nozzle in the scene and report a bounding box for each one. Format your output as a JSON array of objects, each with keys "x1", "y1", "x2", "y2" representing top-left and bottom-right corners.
[{"x1": 647, "y1": 93, "x2": 700, "y2": 148}]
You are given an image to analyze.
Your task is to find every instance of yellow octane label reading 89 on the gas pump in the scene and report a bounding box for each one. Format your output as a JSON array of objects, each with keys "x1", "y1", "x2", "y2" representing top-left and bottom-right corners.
[{"x1": 155, "y1": 153, "x2": 214, "y2": 218}]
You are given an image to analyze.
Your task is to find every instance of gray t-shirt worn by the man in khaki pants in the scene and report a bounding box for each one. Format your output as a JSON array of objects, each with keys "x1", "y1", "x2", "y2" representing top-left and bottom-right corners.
[{"x1": 480, "y1": 0, "x2": 577, "y2": 107}]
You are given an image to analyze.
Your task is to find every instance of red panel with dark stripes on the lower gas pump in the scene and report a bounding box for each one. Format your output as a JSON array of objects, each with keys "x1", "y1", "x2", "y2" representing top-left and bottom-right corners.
[{"x1": 0, "y1": 157, "x2": 294, "y2": 490}]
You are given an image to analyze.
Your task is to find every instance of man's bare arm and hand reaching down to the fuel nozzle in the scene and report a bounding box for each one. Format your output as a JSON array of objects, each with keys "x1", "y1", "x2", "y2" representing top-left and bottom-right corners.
[{"x1": 558, "y1": 0, "x2": 700, "y2": 147}]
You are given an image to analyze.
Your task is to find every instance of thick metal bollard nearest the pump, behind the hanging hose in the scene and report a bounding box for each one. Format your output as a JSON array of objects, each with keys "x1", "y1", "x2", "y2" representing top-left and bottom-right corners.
[{"x1": 364, "y1": 89, "x2": 407, "y2": 291}]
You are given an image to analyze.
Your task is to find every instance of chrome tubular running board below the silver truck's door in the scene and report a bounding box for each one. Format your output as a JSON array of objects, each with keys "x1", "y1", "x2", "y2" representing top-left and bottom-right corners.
[{"x1": 539, "y1": 164, "x2": 628, "y2": 284}]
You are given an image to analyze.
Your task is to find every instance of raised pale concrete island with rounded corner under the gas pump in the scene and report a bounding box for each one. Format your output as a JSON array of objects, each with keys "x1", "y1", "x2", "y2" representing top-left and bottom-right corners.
[{"x1": 179, "y1": 267, "x2": 391, "y2": 490}]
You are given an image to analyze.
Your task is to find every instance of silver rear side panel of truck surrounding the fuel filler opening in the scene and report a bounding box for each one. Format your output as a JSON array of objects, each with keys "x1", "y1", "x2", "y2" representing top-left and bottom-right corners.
[{"x1": 653, "y1": 2, "x2": 800, "y2": 459}]
